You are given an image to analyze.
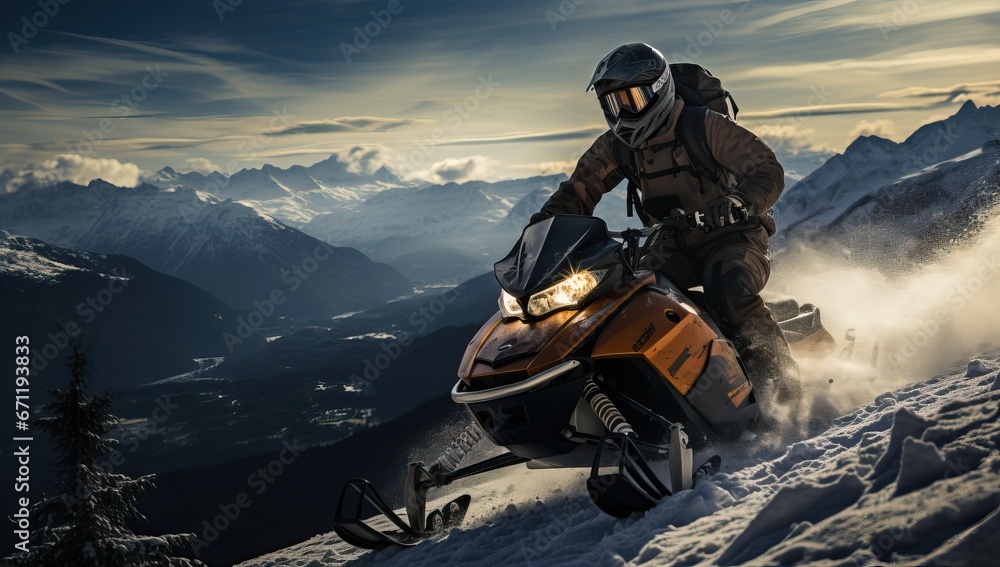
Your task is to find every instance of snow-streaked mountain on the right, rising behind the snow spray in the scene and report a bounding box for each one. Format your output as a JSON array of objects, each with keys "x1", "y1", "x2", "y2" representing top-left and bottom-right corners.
[{"x1": 775, "y1": 101, "x2": 1000, "y2": 263}]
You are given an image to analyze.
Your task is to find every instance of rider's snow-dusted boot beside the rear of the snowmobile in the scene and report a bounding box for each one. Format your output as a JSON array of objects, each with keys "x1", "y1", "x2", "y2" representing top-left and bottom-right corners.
[{"x1": 733, "y1": 316, "x2": 802, "y2": 404}]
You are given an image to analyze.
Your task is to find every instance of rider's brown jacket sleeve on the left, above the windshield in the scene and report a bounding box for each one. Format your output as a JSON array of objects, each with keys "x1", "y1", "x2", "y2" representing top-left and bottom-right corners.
[{"x1": 542, "y1": 130, "x2": 624, "y2": 215}]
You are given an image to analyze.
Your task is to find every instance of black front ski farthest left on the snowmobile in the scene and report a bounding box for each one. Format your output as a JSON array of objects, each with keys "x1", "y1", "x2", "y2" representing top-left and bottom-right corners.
[{"x1": 333, "y1": 479, "x2": 472, "y2": 549}]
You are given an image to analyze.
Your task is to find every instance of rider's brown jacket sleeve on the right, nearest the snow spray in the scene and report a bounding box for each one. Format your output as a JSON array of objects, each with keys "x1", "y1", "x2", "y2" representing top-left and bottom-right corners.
[{"x1": 705, "y1": 112, "x2": 785, "y2": 213}]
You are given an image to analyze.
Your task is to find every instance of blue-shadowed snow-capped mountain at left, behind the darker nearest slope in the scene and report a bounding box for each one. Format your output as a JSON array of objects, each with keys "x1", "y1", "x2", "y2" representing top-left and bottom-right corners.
[{"x1": 0, "y1": 180, "x2": 412, "y2": 318}]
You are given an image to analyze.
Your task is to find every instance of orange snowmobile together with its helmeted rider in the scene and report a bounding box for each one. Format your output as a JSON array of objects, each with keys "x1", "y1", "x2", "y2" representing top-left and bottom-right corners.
[{"x1": 334, "y1": 44, "x2": 833, "y2": 549}]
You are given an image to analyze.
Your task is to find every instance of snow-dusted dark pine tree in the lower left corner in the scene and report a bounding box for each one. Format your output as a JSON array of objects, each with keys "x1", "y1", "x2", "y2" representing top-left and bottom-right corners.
[{"x1": 11, "y1": 344, "x2": 204, "y2": 567}]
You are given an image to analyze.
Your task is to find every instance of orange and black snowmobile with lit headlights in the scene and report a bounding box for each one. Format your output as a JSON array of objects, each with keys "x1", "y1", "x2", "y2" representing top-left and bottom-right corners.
[{"x1": 334, "y1": 210, "x2": 833, "y2": 549}]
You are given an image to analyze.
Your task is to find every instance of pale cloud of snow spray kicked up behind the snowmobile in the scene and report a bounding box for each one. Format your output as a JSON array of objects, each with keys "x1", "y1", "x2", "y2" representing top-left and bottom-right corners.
[{"x1": 767, "y1": 211, "x2": 1000, "y2": 432}]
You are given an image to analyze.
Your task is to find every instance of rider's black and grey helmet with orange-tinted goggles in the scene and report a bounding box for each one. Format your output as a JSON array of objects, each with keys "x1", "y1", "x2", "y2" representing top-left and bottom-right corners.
[{"x1": 587, "y1": 43, "x2": 674, "y2": 149}]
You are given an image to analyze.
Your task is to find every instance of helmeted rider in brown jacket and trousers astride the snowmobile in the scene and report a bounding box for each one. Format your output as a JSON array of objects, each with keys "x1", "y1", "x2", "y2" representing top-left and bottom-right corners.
[{"x1": 532, "y1": 43, "x2": 799, "y2": 398}]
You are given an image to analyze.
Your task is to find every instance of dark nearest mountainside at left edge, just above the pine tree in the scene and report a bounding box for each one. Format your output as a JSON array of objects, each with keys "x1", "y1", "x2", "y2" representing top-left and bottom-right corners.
[{"x1": 0, "y1": 231, "x2": 264, "y2": 388}]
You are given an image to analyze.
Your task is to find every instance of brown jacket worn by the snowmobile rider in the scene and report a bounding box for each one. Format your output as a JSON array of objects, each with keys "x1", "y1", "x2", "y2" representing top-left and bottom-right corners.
[{"x1": 542, "y1": 99, "x2": 785, "y2": 242}]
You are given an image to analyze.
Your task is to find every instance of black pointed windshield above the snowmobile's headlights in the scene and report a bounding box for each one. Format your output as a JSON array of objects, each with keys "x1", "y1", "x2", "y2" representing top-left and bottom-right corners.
[{"x1": 494, "y1": 215, "x2": 622, "y2": 298}]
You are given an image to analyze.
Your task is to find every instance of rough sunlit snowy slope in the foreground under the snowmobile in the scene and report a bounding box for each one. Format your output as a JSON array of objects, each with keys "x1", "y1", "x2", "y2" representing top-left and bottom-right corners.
[{"x1": 236, "y1": 353, "x2": 1000, "y2": 567}]
